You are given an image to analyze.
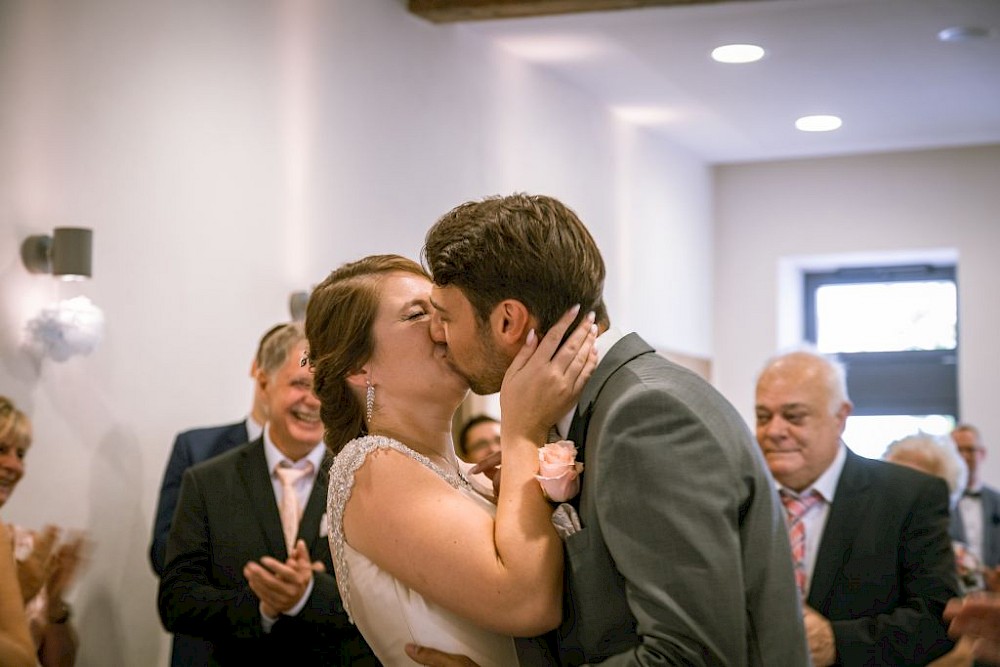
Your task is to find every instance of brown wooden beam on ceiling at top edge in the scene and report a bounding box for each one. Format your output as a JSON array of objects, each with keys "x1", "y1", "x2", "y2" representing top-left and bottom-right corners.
[{"x1": 409, "y1": 0, "x2": 744, "y2": 23}]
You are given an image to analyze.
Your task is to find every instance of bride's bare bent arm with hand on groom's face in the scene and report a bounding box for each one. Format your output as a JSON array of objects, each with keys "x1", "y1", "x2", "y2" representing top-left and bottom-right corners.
[{"x1": 344, "y1": 313, "x2": 596, "y2": 636}]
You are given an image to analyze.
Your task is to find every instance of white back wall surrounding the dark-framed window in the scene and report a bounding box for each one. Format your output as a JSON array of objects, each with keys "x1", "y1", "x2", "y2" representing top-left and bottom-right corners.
[{"x1": 713, "y1": 146, "x2": 1000, "y2": 474}]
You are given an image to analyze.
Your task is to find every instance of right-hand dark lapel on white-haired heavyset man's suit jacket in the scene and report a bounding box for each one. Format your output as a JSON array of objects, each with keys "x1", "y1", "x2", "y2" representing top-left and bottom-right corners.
[{"x1": 808, "y1": 450, "x2": 871, "y2": 614}]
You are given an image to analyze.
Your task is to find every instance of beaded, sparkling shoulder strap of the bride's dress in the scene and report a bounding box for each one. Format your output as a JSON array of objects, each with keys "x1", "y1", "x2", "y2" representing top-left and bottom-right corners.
[{"x1": 326, "y1": 435, "x2": 473, "y2": 623}]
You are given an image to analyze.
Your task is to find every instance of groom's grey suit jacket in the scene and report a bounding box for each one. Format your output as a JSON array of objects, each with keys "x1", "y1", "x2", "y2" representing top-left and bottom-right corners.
[{"x1": 558, "y1": 334, "x2": 809, "y2": 667}]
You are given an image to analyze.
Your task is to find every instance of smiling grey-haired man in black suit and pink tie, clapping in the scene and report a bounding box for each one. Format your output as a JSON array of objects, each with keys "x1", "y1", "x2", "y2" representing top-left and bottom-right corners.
[{"x1": 159, "y1": 323, "x2": 377, "y2": 667}]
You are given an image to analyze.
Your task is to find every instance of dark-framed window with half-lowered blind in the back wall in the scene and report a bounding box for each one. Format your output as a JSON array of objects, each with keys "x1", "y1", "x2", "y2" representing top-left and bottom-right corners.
[{"x1": 804, "y1": 266, "x2": 958, "y2": 458}]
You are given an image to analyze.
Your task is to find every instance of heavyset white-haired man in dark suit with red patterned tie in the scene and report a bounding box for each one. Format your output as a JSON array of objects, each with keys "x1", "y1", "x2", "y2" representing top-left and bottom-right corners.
[{"x1": 756, "y1": 351, "x2": 959, "y2": 667}]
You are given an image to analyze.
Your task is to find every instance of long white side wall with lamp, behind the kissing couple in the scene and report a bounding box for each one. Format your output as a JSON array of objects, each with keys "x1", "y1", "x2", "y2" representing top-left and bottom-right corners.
[{"x1": 0, "y1": 0, "x2": 712, "y2": 667}]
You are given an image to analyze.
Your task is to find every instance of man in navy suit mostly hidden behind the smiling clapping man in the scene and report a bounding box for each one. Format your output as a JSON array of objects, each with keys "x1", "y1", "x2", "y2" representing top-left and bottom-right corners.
[{"x1": 149, "y1": 324, "x2": 284, "y2": 667}]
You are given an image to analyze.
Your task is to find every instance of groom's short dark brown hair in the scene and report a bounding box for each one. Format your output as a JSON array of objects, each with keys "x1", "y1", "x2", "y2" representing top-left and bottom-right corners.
[{"x1": 423, "y1": 193, "x2": 608, "y2": 335}]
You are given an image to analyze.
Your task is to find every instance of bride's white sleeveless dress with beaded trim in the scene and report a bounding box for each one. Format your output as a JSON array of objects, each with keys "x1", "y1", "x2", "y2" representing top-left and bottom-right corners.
[{"x1": 327, "y1": 435, "x2": 517, "y2": 667}]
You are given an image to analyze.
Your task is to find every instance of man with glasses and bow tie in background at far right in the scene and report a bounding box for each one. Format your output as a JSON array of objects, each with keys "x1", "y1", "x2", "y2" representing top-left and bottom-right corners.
[{"x1": 951, "y1": 424, "x2": 1000, "y2": 584}]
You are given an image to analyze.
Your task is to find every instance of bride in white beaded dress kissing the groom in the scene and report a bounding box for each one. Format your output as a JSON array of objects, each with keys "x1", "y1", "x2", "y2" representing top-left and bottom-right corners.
[{"x1": 306, "y1": 255, "x2": 596, "y2": 667}]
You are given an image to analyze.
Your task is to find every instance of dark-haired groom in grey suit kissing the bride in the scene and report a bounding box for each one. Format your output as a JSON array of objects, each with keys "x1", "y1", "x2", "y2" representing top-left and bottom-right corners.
[{"x1": 416, "y1": 194, "x2": 809, "y2": 667}]
